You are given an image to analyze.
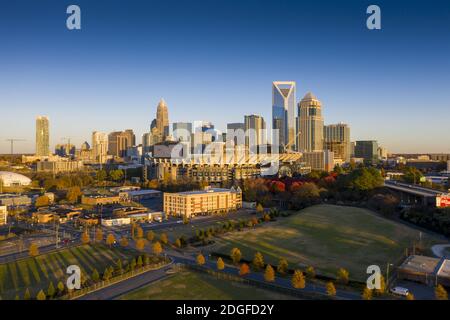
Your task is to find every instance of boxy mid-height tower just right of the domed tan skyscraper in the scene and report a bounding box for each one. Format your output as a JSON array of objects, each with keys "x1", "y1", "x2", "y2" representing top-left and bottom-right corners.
[{"x1": 323, "y1": 123, "x2": 351, "y2": 162}]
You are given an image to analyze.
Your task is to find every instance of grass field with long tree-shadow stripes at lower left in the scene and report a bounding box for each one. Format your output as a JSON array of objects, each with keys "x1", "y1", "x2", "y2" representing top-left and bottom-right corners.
[{"x1": 0, "y1": 245, "x2": 132, "y2": 299}]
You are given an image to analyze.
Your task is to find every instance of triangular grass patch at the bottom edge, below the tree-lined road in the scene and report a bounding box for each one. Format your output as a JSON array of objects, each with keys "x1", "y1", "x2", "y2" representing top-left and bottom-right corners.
[{"x1": 119, "y1": 271, "x2": 293, "y2": 300}]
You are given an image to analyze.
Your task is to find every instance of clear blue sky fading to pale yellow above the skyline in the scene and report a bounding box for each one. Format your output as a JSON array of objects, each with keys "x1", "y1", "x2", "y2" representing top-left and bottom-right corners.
[{"x1": 0, "y1": 0, "x2": 450, "y2": 153}]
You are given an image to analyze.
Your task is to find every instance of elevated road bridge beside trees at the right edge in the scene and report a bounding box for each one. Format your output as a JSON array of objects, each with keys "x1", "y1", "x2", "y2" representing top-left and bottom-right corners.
[{"x1": 384, "y1": 180, "x2": 445, "y2": 207}]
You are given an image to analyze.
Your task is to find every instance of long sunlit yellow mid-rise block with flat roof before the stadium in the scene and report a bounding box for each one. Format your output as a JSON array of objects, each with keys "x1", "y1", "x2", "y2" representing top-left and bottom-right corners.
[{"x1": 164, "y1": 187, "x2": 242, "y2": 218}]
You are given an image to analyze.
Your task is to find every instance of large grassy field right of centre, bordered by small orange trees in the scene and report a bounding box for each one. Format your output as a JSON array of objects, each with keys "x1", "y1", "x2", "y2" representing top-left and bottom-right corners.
[{"x1": 211, "y1": 205, "x2": 442, "y2": 280}]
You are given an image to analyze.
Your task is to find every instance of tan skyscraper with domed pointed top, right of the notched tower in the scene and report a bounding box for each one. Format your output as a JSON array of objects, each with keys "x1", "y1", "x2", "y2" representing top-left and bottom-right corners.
[{"x1": 297, "y1": 92, "x2": 324, "y2": 152}]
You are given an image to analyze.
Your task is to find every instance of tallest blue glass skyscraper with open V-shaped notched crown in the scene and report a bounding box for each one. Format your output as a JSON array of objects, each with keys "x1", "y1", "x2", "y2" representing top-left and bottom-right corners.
[{"x1": 272, "y1": 81, "x2": 296, "y2": 152}]
